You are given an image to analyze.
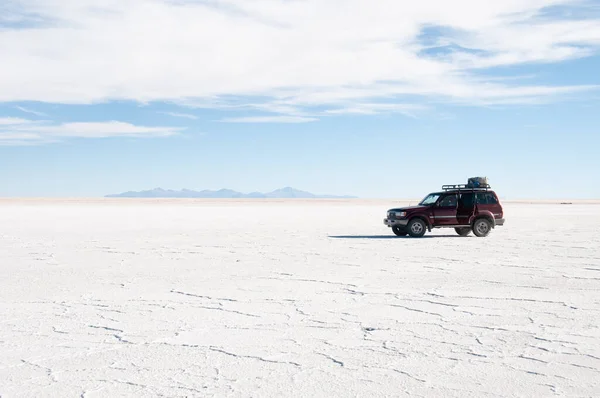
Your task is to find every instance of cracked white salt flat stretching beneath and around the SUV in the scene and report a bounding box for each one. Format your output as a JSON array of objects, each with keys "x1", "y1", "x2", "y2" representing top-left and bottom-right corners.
[{"x1": 0, "y1": 199, "x2": 600, "y2": 398}]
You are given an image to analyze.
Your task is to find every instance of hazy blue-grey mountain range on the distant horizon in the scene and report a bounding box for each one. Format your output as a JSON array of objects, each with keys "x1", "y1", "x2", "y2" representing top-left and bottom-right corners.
[{"x1": 106, "y1": 187, "x2": 356, "y2": 199}]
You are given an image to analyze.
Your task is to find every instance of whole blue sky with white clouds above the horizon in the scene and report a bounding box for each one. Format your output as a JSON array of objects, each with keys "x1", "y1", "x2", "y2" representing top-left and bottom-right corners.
[{"x1": 0, "y1": 0, "x2": 600, "y2": 199}]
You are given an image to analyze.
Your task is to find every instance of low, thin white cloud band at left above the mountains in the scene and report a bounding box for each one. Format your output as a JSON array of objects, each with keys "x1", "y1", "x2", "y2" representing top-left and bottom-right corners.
[{"x1": 0, "y1": 118, "x2": 183, "y2": 145}]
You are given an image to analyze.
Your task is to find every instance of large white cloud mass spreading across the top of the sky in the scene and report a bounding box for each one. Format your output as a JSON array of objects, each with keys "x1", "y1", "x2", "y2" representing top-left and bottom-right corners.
[{"x1": 0, "y1": 0, "x2": 600, "y2": 117}]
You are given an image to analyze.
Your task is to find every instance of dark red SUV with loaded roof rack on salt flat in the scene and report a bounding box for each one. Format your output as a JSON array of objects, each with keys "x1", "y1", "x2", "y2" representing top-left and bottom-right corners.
[{"x1": 383, "y1": 183, "x2": 504, "y2": 237}]
